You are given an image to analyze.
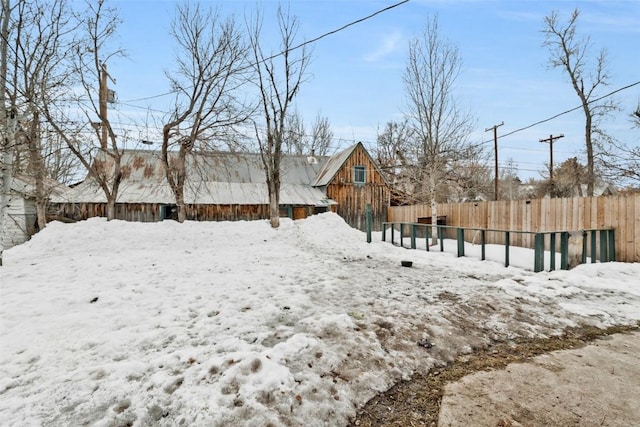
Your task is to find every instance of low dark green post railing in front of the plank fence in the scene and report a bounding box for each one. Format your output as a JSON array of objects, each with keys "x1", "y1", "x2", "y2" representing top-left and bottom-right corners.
[{"x1": 382, "y1": 222, "x2": 615, "y2": 272}]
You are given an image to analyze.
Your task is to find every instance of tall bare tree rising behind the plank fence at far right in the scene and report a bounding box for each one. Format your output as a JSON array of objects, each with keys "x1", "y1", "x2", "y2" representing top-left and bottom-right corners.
[{"x1": 542, "y1": 9, "x2": 617, "y2": 196}]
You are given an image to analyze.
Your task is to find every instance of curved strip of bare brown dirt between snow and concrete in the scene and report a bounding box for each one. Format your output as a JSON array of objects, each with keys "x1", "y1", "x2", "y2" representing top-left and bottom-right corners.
[{"x1": 350, "y1": 326, "x2": 638, "y2": 427}]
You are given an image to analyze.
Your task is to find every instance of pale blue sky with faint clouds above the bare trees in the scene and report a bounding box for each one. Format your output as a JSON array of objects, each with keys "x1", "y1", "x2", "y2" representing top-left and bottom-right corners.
[{"x1": 109, "y1": 0, "x2": 640, "y2": 179}]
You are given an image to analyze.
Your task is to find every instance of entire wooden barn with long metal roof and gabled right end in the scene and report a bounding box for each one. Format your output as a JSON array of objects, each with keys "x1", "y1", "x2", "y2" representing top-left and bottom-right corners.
[{"x1": 51, "y1": 143, "x2": 389, "y2": 229}]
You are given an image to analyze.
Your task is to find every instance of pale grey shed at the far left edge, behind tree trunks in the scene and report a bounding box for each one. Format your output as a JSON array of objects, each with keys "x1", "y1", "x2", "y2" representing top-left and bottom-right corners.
[{"x1": 3, "y1": 174, "x2": 68, "y2": 249}]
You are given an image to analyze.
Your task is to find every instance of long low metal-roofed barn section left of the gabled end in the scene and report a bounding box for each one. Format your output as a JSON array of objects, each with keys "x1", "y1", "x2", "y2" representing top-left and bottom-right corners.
[{"x1": 52, "y1": 150, "x2": 336, "y2": 222}]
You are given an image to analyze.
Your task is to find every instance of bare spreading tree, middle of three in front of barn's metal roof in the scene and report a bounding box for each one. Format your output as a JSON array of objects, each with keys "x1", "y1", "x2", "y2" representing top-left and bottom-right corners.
[{"x1": 162, "y1": 2, "x2": 250, "y2": 222}]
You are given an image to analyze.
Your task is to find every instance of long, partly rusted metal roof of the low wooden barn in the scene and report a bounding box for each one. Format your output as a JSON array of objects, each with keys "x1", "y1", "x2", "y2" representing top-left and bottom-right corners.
[{"x1": 52, "y1": 150, "x2": 336, "y2": 206}]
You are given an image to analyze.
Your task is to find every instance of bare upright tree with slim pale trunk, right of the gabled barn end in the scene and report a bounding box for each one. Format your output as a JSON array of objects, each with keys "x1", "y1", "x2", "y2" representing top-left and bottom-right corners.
[{"x1": 404, "y1": 17, "x2": 479, "y2": 243}]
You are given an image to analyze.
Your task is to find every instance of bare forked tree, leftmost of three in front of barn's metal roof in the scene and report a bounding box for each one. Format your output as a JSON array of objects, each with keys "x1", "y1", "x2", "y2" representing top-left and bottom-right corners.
[{"x1": 40, "y1": 0, "x2": 126, "y2": 220}]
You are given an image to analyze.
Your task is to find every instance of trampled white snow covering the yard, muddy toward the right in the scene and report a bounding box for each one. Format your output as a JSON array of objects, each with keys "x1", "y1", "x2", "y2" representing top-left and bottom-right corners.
[{"x1": 0, "y1": 214, "x2": 640, "y2": 426}]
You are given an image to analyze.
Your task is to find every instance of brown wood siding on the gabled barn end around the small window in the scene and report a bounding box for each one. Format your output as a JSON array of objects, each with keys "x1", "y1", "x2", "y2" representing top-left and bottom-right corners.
[{"x1": 327, "y1": 146, "x2": 391, "y2": 230}]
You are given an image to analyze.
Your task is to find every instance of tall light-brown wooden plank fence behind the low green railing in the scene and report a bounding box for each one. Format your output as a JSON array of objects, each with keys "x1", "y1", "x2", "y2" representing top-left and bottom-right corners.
[{"x1": 388, "y1": 194, "x2": 640, "y2": 262}]
